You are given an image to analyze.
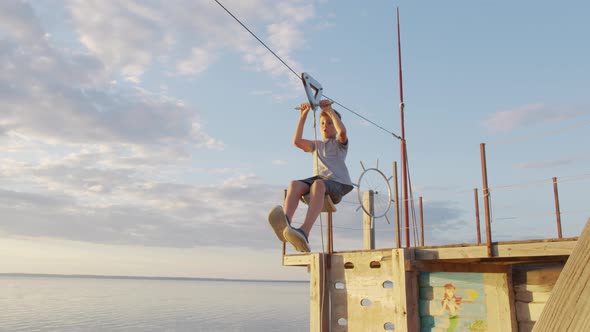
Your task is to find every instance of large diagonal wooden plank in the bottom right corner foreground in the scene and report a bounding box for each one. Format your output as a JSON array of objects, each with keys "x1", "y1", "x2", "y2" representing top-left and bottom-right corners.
[{"x1": 533, "y1": 219, "x2": 590, "y2": 332}]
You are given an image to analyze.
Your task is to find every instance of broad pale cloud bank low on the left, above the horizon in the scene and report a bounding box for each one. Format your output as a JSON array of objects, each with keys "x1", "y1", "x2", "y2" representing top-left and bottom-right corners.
[{"x1": 0, "y1": 167, "x2": 282, "y2": 248}]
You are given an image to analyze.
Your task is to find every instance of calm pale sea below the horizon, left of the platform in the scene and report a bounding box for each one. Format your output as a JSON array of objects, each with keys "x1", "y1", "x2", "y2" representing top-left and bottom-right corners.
[{"x1": 0, "y1": 275, "x2": 309, "y2": 332}]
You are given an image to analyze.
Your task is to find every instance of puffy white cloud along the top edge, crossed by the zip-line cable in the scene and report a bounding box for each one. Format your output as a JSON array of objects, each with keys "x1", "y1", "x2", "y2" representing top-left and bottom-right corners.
[{"x1": 62, "y1": 0, "x2": 315, "y2": 83}]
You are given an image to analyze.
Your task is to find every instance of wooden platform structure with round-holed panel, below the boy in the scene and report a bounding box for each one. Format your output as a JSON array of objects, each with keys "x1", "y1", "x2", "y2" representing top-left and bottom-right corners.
[{"x1": 282, "y1": 238, "x2": 578, "y2": 332}]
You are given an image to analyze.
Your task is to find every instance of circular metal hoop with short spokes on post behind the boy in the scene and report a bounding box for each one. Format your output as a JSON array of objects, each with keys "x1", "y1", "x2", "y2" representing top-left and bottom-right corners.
[{"x1": 357, "y1": 168, "x2": 391, "y2": 218}]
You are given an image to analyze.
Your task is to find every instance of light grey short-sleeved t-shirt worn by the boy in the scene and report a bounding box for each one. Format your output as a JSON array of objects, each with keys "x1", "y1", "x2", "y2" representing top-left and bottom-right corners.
[{"x1": 311, "y1": 138, "x2": 352, "y2": 186}]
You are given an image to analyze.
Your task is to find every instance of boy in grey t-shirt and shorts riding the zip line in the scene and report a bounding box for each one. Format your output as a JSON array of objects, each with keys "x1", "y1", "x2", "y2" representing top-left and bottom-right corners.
[{"x1": 268, "y1": 100, "x2": 352, "y2": 252}]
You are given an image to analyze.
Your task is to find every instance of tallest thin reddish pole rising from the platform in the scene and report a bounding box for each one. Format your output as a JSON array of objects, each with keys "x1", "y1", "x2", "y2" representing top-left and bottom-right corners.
[{"x1": 397, "y1": 7, "x2": 410, "y2": 248}]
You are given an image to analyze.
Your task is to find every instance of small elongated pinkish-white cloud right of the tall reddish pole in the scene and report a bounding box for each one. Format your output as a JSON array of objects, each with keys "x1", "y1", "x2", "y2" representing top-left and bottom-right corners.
[{"x1": 484, "y1": 103, "x2": 571, "y2": 132}]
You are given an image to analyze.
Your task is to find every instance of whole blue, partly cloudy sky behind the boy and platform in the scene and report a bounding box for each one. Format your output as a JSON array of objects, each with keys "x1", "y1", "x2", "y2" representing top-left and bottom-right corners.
[{"x1": 0, "y1": 0, "x2": 590, "y2": 280}]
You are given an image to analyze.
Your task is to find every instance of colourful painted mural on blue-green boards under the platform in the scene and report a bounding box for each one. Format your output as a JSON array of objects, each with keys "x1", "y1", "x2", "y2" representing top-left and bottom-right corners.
[{"x1": 419, "y1": 272, "x2": 487, "y2": 332}]
